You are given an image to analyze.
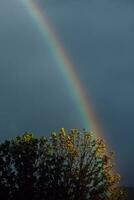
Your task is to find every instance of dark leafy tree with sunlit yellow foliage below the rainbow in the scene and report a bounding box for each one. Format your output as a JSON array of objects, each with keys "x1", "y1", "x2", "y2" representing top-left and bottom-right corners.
[{"x1": 0, "y1": 128, "x2": 124, "y2": 200}]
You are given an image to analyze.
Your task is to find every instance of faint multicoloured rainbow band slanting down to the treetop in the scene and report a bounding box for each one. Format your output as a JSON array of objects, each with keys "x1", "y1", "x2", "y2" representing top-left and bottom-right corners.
[{"x1": 22, "y1": 0, "x2": 102, "y2": 136}]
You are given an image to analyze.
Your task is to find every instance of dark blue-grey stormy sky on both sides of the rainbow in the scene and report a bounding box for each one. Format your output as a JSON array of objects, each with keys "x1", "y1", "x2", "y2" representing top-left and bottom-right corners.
[{"x1": 0, "y1": 0, "x2": 134, "y2": 185}]
